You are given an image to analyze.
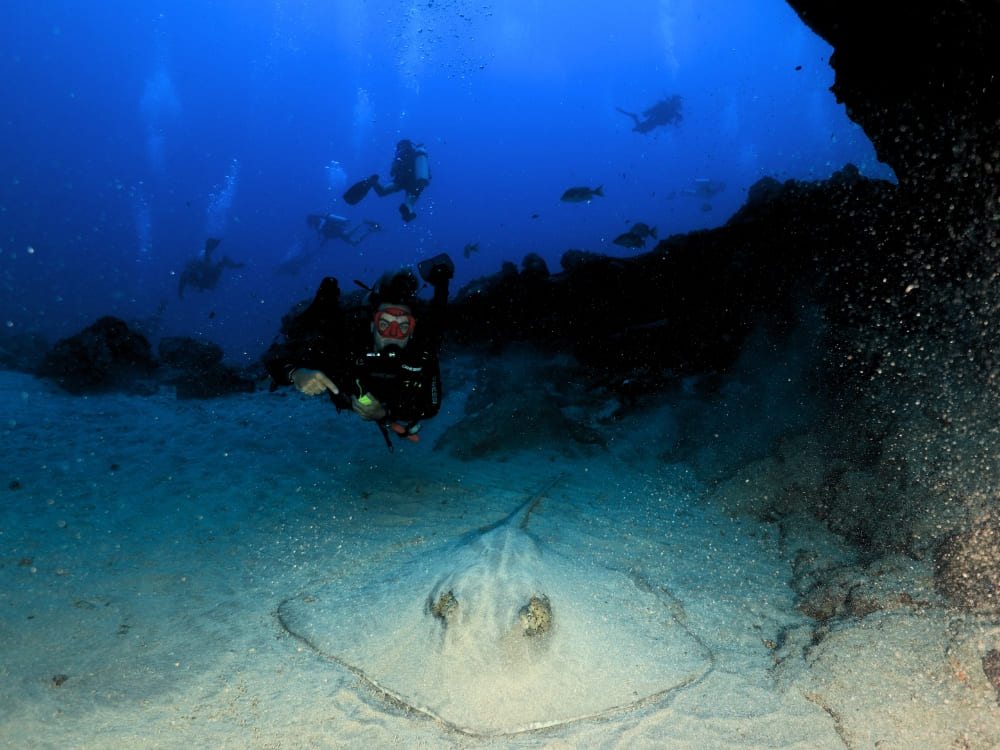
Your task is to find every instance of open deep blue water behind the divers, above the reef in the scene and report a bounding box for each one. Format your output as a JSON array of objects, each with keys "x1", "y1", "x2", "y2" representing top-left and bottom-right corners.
[{"x1": 0, "y1": 0, "x2": 892, "y2": 362}]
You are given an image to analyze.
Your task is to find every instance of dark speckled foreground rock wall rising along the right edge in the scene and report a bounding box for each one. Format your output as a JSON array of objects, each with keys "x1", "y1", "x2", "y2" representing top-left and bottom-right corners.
[{"x1": 788, "y1": 0, "x2": 1000, "y2": 611}]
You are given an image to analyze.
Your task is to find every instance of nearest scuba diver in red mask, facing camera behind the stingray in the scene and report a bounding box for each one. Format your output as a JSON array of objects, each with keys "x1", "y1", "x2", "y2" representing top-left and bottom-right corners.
[{"x1": 263, "y1": 254, "x2": 455, "y2": 450}]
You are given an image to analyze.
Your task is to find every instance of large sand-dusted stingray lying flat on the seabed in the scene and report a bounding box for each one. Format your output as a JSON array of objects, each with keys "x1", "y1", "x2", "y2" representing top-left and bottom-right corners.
[{"x1": 277, "y1": 478, "x2": 712, "y2": 736}]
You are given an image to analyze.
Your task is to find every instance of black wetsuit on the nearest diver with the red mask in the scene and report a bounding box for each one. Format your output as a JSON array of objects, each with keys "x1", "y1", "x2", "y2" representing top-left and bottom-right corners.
[{"x1": 264, "y1": 278, "x2": 448, "y2": 424}]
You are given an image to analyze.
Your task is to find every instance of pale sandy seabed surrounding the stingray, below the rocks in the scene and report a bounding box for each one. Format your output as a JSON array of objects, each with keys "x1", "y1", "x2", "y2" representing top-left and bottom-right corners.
[{"x1": 0, "y1": 363, "x2": 1000, "y2": 750}]
